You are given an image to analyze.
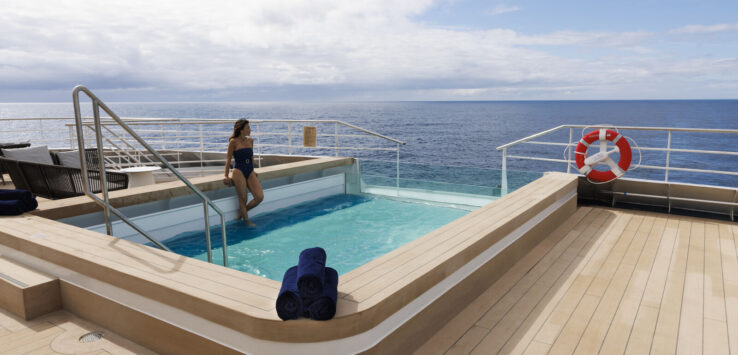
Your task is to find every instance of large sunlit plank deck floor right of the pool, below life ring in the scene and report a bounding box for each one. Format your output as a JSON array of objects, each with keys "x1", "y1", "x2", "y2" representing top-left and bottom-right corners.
[{"x1": 417, "y1": 207, "x2": 738, "y2": 354}]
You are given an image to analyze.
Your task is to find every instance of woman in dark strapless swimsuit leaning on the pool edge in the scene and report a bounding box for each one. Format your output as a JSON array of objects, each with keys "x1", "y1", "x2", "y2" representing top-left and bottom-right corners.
[{"x1": 223, "y1": 118, "x2": 264, "y2": 226}]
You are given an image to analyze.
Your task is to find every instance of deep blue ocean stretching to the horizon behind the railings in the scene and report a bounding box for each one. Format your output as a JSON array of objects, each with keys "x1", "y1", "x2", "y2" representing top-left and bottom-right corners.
[{"x1": 0, "y1": 100, "x2": 738, "y2": 187}]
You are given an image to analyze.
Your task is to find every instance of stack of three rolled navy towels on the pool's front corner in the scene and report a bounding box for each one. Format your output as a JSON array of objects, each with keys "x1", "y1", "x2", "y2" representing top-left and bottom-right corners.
[{"x1": 277, "y1": 247, "x2": 338, "y2": 320}]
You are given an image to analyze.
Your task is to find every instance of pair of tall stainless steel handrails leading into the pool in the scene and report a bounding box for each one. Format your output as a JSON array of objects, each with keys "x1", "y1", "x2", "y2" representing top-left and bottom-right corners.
[{"x1": 72, "y1": 85, "x2": 228, "y2": 266}]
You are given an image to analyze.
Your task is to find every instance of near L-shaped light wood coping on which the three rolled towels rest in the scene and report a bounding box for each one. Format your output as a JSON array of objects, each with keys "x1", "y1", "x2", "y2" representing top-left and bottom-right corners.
[{"x1": 0, "y1": 173, "x2": 577, "y2": 342}]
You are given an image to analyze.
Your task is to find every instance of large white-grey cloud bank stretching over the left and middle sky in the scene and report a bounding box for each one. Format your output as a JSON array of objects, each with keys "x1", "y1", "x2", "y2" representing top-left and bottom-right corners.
[{"x1": 0, "y1": 0, "x2": 734, "y2": 100}]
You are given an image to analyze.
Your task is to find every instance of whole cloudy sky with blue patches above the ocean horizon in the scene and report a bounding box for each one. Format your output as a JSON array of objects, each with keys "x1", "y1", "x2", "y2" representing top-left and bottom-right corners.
[{"x1": 0, "y1": 0, "x2": 738, "y2": 102}]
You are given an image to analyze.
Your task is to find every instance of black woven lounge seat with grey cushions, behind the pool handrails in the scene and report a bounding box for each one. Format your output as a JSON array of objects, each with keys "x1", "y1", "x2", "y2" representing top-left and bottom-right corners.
[{"x1": 0, "y1": 150, "x2": 128, "y2": 199}]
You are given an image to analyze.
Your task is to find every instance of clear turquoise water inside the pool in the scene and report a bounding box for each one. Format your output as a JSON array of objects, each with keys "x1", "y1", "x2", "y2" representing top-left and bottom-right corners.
[{"x1": 165, "y1": 194, "x2": 469, "y2": 281}]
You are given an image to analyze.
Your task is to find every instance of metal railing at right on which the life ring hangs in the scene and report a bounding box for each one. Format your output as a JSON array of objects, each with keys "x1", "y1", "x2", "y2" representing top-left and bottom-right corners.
[{"x1": 497, "y1": 125, "x2": 738, "y2": 195}]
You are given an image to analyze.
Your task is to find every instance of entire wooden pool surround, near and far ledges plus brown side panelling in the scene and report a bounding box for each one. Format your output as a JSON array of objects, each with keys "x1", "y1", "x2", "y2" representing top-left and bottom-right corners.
[{"x1": 0, "y1": 158, "x2": 577, "y2": 352}]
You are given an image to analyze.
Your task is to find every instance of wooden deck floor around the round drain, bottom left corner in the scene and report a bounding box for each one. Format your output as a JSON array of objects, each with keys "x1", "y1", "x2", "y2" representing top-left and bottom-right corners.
[{"x1": 0, "y1": 309, "x2": 153, "y2": 355}]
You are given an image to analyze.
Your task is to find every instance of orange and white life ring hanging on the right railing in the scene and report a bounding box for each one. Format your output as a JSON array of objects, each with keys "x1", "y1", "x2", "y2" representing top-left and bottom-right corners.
[{"x1": 575, "y1": 128, "x2": 633, "y2": 182}]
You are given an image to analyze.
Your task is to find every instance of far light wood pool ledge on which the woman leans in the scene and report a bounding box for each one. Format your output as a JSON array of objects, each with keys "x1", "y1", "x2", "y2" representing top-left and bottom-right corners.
[{"x1": 30, "y1": 157, "x2": 354, "y2": 219}]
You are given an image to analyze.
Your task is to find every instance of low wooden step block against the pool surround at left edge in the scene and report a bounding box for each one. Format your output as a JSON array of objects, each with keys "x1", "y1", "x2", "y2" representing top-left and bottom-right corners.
[{"x1": 0, "y1": 256, "x2": 61, "y2": 320}]
